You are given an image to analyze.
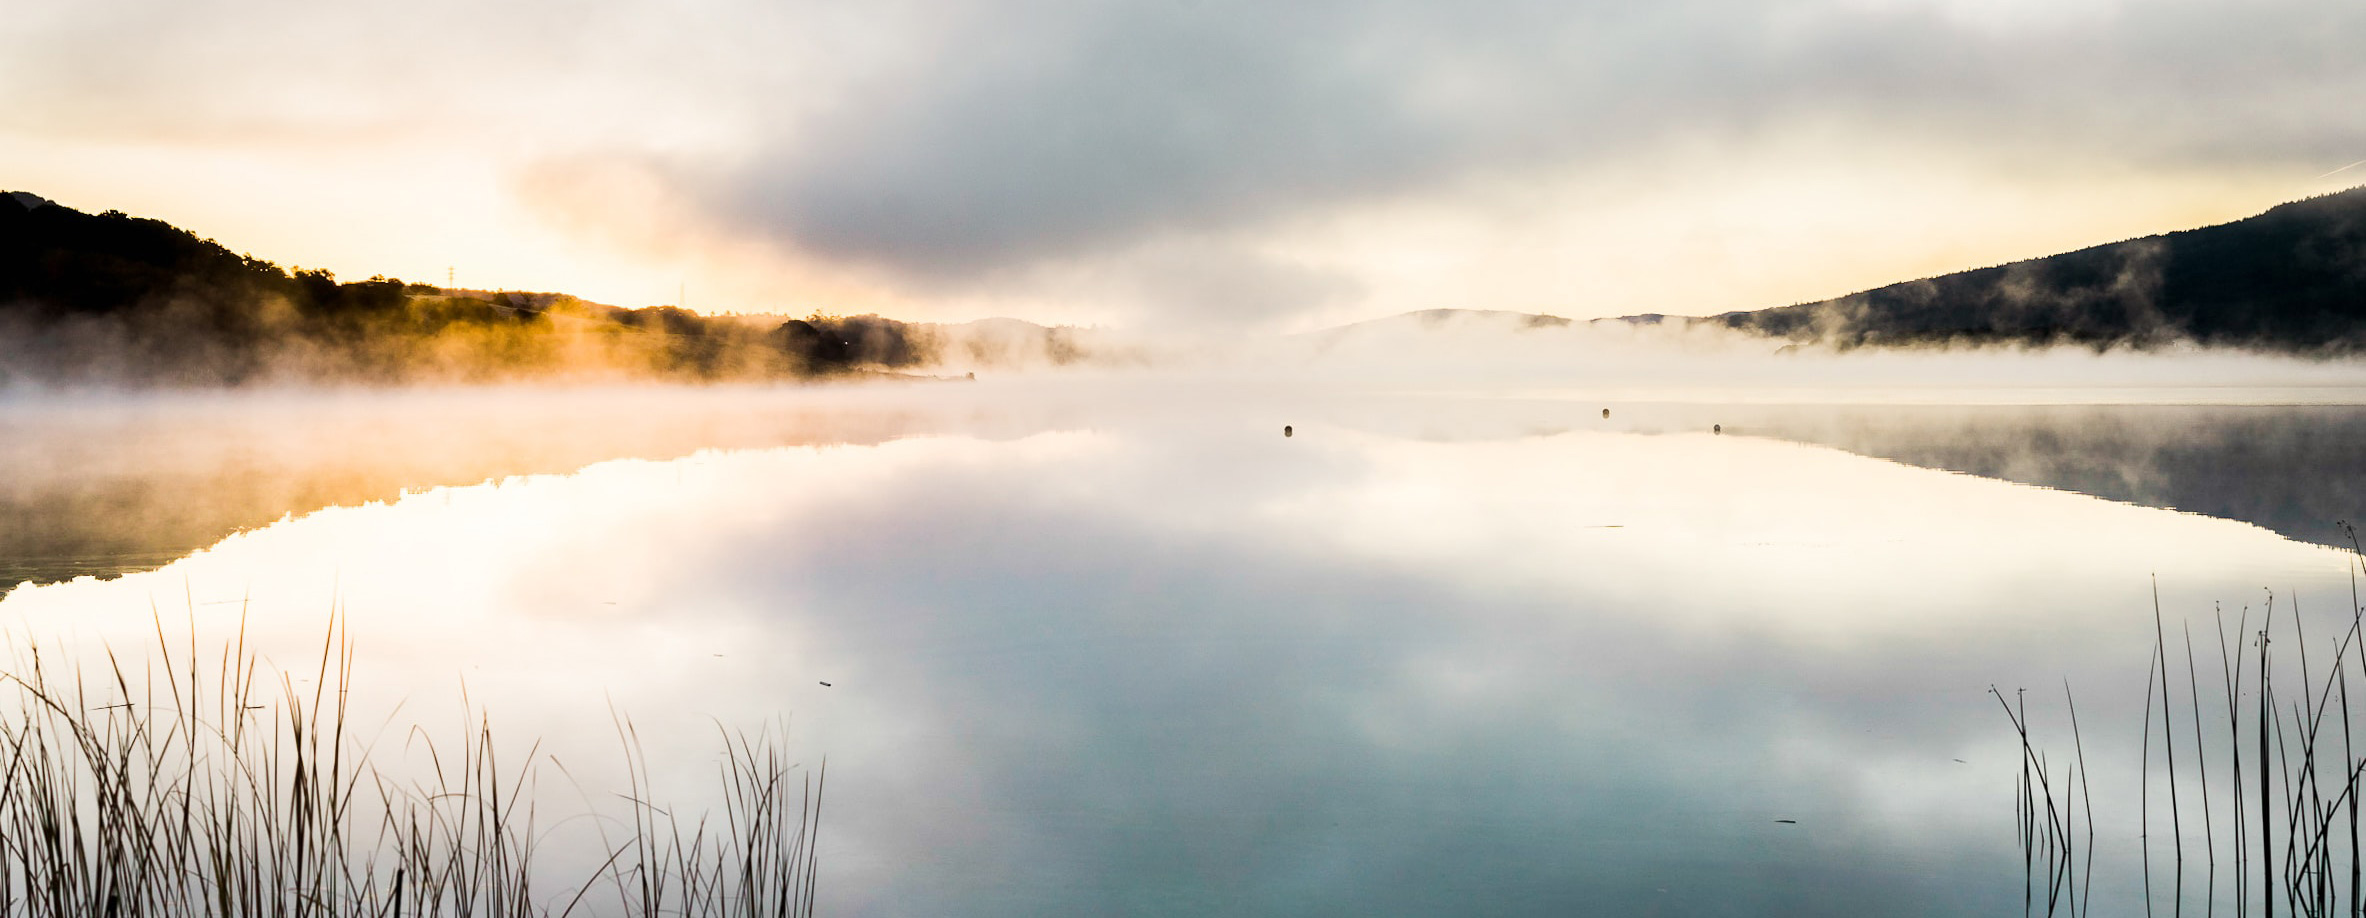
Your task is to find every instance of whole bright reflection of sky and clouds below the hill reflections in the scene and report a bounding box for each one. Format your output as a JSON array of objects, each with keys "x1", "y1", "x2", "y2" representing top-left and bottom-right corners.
[{"x1": 0, "y1": 425, "x2": 2342, "y2": 913}]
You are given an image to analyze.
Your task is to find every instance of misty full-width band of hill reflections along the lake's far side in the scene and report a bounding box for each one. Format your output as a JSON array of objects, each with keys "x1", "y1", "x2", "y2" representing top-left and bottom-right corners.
[{"x1": 13, "y1": 386, "x2": 2366, "y2": 594}]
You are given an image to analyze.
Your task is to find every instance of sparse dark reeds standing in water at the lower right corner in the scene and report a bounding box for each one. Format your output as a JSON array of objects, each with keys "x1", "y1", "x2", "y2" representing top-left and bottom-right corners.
[{"x1": 1990, "y1": 525, "x2": 2366, "y2": 918}]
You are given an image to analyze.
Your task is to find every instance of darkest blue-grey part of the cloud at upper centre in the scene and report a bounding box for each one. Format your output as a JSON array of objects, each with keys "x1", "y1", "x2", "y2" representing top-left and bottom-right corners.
[{"x1": 709, "y1": 2, "x2": 1457, "y2": 274}]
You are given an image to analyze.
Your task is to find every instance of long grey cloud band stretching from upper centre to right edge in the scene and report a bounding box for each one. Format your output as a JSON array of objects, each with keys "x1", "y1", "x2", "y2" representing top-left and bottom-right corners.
[{"x1": 715, "y1": 0, "x2": 2366, "y2": 279}]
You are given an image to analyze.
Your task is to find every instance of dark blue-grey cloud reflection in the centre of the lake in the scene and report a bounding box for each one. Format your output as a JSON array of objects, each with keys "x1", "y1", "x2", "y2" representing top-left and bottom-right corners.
[{"x1": 695, "y1": 440, "x2": 1977, "y2": 913}]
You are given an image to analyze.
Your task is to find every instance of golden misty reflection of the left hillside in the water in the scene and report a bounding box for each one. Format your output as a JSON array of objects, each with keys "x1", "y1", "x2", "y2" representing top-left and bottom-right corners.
[{"x1": 0, "y1": 388, "x2": 1003, "y2": 594}]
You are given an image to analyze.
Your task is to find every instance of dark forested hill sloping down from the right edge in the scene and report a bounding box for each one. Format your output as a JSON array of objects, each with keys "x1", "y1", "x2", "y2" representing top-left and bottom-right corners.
[{"x1": 1706, "y1": 187, "x2": 2366, "y2": 355}]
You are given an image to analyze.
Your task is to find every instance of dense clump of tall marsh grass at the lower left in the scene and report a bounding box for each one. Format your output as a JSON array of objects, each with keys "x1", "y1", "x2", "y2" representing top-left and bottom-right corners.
[{"x1": 0, "y1": 622, "x2": 823, "y2": 918}]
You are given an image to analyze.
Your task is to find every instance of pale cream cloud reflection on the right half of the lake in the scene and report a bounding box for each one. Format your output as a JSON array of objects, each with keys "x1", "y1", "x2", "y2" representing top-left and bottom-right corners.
[{"x1": 1282, "y1": 433, "x2": 2340, "y2": 641}]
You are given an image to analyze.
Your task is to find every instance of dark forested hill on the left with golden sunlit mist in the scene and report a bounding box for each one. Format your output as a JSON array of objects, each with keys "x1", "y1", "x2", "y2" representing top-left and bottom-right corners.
[{"x1": 0, "y1": 192, "x2": 927, "y2": 388}]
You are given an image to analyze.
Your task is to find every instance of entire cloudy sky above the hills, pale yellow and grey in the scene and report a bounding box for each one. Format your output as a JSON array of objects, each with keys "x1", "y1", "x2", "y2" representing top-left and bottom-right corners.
[{"x1": 0, "y1": 0, "x2": 2366, "y2": 331}]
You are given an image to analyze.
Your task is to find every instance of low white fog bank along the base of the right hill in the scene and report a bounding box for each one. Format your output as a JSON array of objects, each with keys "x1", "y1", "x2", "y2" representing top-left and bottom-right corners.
[{"x1": 1202, "y1": 310, "x2": 2366, "y2": 402}]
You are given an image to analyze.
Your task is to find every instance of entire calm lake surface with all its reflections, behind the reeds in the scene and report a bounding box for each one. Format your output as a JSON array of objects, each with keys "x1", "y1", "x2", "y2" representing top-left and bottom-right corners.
[{"x1": 0, "y1": 379, "x2": 2366, "y2": 916}]
